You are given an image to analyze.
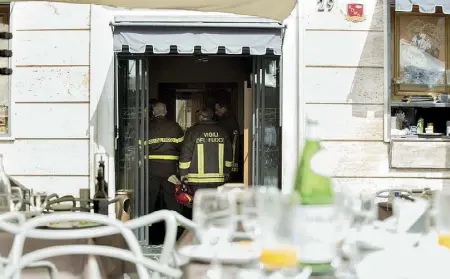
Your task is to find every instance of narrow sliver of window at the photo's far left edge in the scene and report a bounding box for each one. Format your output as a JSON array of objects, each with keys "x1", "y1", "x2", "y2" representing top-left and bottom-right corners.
[{"x1": 0, "y1": 5, "x2": 10, "y2": 135}]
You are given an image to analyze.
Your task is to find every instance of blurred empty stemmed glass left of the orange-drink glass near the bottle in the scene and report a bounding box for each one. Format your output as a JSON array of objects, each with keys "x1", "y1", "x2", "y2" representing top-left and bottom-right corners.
[{"x1": 193, "y1": 189, "x2": 236, "y2": 279}]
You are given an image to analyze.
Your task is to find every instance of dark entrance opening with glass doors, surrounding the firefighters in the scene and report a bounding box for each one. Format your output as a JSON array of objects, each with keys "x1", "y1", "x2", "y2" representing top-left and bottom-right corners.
[{"x1": 115, "y1": 53, "x2": 282, "y2": 243}]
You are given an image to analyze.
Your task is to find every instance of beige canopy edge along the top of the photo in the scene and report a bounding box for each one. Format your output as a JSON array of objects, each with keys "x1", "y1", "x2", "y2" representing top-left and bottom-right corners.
[{"x1": 11, "y1": 0, "x2": 297, "y2": 21}]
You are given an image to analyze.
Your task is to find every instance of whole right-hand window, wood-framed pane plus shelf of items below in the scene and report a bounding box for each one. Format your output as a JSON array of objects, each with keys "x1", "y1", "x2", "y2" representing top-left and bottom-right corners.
[{"x1": 389, "y1": 7, "x2": 450, "y2": 139}]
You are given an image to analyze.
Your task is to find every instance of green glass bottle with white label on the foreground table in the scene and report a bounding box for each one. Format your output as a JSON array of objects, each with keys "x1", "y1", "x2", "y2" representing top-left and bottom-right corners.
[{"x1": 294, "y1": 120, "x2": 336, "y2": 274}]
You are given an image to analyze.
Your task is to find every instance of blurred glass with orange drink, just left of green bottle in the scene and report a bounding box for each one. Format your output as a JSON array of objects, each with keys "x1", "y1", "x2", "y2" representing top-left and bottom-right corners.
[{"x1": 238, "y1": 186, "x2": 298, "y2": 278}]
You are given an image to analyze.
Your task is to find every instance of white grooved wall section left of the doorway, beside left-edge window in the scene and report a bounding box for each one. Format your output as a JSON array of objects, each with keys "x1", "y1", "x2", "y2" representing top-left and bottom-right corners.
[{"x1": 0, "y1": 2, "x2": 90, "y2": 198}]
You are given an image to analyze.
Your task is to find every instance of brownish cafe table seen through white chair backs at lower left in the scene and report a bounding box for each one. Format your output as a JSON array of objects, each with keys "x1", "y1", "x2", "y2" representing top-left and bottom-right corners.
[{"x1": 0, "y1": 232, "x2": 127, "y2": 279}]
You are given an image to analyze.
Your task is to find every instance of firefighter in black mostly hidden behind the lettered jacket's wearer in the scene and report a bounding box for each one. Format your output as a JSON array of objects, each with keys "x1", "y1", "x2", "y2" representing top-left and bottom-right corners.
[{"x1": 215, "y1": 101, "x2": 242, "y2": 182}]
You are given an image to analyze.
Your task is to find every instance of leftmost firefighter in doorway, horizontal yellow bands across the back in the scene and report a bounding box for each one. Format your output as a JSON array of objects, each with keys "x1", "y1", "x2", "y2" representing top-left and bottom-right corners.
[{"x1": 147, "y1": 103, "x2": 183, "y2": 213}]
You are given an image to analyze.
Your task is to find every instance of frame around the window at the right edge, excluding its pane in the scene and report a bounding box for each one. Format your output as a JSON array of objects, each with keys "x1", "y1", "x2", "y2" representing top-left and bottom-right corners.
[{"x1": 384, "y1": 6, "x2": 450, "y2": 142}]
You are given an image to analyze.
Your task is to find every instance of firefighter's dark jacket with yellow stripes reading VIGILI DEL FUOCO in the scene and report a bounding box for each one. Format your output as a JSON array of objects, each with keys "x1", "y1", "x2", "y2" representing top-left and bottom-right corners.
[{"x1": 180, "y1": 121, "x2": 232, "y2": 184}]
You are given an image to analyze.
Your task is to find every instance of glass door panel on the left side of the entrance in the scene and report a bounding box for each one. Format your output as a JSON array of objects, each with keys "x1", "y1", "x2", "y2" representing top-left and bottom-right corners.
[{"x1": 115, "y1": 57, "x2": 150, "y2": 245}]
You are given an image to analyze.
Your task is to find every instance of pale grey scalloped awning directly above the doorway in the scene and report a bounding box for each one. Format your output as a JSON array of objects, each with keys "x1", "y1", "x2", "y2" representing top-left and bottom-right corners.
[{"x1": 112, "y1": 16, "x2": 283, "y2": 55}]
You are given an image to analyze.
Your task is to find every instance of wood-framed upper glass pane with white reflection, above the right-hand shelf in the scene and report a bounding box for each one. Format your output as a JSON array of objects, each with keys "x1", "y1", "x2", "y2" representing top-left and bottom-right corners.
[{"x1": 394, "y1": 13, "x2": 447, "y2": 96}]
